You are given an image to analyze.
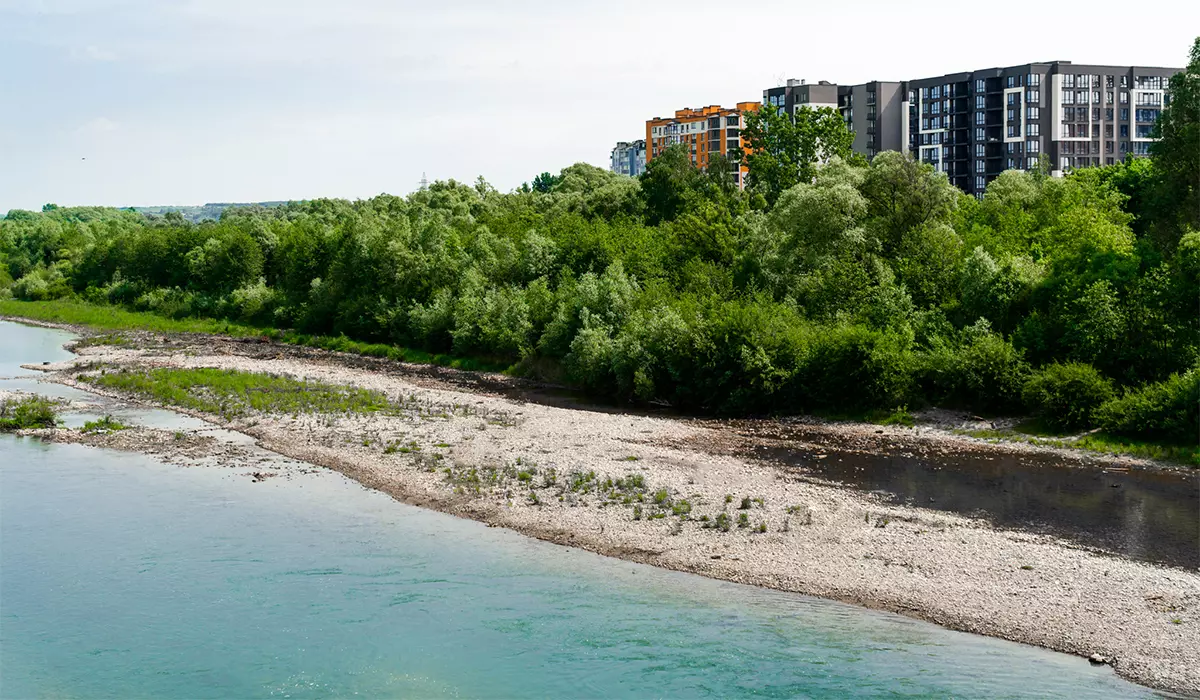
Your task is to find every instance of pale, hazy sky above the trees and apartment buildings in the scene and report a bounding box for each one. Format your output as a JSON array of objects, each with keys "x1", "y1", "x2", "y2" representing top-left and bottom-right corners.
[{"x1": 0, "y1": 0, "x2": 1200, "y2": 213}]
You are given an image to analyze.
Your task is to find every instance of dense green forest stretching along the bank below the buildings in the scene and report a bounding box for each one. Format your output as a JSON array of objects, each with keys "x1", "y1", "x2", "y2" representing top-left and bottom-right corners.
[{"x1": 0, "y1": 40, "x2": 1200, "y2": 444}]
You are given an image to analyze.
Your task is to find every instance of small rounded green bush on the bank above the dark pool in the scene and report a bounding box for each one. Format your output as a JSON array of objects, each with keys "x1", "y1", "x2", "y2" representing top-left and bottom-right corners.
[{"x1": 1021, "y1": 363, "x2": 1112, "y2": 430}]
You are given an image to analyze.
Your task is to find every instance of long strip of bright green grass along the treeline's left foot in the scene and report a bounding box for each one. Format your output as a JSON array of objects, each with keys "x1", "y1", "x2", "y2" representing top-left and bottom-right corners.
[{"x1": 0, "y1": 299, "x2": 512, "y2": 372}]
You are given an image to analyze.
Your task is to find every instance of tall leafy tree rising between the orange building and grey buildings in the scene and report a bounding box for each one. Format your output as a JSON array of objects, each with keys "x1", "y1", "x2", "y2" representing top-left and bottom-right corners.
[{"x1": 738, "y1": 107, "x2": 854, "y2": 204}]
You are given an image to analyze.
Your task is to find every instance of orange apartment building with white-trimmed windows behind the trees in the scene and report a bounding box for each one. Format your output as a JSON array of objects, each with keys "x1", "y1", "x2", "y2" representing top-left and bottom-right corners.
[{"x1": 646, "y1": 102, "x2": 761, "y2": 187}]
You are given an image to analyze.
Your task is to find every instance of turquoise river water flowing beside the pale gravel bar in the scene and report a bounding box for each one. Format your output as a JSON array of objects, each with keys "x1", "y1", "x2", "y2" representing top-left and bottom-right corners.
[{"x1": 0, "y1": 323, "x2": 1151, "y2": 699}]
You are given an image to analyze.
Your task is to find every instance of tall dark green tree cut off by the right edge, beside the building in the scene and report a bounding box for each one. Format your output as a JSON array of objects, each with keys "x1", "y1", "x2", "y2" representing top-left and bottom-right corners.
[{"x1": 1150, "y1": 37, "x2": 1200, "y2": 233}]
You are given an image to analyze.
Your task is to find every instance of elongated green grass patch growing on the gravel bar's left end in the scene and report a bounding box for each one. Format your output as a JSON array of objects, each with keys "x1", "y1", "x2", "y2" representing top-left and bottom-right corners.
[{"x1": 84, "y1": 369, "x2": 400, "y2": 418}]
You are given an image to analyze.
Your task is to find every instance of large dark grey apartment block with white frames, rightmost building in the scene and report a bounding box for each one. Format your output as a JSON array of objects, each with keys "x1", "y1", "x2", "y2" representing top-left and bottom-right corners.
[{"x1": 907, "y1": 61, "x2": 1180, "y2": 196}]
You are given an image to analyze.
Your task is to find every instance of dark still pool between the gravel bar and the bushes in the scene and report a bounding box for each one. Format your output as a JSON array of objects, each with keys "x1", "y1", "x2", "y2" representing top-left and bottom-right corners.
[{"x1": 755, "y1": 441, "x2": 1200, "y2": 569}]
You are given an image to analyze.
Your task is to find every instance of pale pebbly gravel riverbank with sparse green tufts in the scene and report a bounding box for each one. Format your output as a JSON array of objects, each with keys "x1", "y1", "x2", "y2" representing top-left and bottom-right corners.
[{"x1": 9, "y1": 319, "x2": 1200, "y2": 692}]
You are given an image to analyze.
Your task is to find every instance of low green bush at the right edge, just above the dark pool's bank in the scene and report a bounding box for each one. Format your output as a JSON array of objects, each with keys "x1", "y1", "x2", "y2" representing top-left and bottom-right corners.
[{"x1": 1096, "y1": 367, "x2": 1200, "y2": 444}]
